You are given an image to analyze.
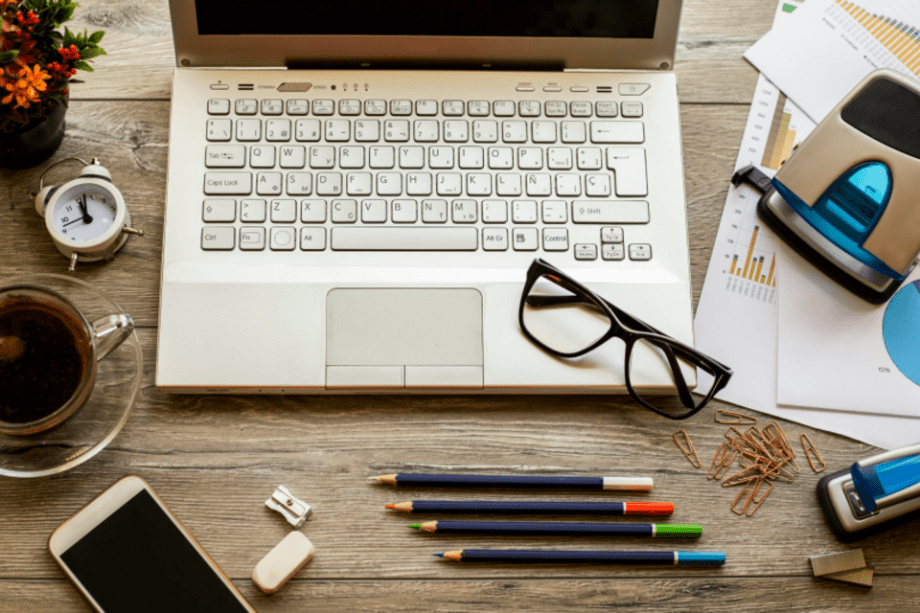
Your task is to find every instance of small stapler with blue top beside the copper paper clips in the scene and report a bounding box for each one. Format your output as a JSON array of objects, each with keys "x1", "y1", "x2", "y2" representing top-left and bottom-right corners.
[{"x1": 818, "y1": 444, "x2": 920, "y2": 542}]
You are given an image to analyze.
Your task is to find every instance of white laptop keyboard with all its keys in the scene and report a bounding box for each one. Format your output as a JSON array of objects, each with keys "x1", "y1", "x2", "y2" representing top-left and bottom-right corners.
[{"x1": 201, "y1": 98, "x2": 652, "y2": 260}]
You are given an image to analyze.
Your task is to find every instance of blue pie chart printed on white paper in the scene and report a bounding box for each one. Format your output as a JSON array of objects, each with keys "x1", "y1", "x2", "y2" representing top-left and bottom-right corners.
[{"x1": 882, "y1": 280, "x2": 920, "y2": 385}]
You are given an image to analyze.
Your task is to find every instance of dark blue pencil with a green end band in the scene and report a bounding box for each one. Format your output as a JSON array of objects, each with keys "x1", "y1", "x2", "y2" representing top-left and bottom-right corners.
[{"x1": 409, "y1": 521, "x2": 703, "y2": 539}]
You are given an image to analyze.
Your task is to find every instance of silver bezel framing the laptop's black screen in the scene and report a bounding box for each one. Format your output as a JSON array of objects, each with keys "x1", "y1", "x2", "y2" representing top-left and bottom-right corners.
[{"x1": 169, "y1": 0, "x2": 683, "y2": 70}]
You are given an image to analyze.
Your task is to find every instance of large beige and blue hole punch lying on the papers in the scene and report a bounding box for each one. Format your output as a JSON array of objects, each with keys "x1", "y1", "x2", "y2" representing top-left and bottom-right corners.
[{"x1": 732, "y1": 69, "x2": 920, "y2": 304}]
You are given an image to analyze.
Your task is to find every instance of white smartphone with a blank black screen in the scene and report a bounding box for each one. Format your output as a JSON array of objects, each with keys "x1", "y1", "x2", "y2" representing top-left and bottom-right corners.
[{"x1": 48, "y1": 475, "x2": 255, "y2": 613}]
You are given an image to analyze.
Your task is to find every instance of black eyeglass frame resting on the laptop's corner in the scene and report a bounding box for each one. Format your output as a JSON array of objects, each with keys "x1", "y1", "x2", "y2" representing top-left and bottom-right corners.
[{"x1": 518, "y1": 258, "x2": 734, "y2": 419}]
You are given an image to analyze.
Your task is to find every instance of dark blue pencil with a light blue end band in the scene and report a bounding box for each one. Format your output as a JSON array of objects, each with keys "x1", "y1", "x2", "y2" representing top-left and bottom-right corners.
[{"x1": 434, "y1": 549, "x2": 725, "y2": 566}]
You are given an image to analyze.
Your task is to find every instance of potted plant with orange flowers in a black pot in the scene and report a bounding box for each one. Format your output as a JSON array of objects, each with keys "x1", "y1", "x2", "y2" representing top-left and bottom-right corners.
[{"x1": 0, "y1": 0, "x2": 105, "y2": 168}]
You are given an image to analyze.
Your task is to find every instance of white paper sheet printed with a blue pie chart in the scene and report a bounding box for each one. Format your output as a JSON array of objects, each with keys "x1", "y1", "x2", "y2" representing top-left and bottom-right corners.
[{"x1": 777, "y1": 247, "x2": 920, "y2": 417}]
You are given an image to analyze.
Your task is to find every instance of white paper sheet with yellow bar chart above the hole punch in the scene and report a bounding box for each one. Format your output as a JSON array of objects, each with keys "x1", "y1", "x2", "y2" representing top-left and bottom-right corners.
[{"x1": 744, "y1": 0, "x2": 920, "y2": 122}]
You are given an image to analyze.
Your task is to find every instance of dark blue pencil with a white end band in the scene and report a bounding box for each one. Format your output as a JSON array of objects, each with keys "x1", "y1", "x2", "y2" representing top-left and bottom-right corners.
[{"x1": 370, "y1": 473, "x2": 653, "y2": 492}]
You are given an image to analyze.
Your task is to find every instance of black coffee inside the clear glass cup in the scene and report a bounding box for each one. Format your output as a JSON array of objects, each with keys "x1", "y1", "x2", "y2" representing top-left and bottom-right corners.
[{"x1": 0, "y1": 299, "x2": 89, "y2": 423}]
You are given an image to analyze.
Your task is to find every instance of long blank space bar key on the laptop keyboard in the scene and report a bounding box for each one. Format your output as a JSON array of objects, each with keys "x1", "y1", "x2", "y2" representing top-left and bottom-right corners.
[{"x1": 331, "y1": 226, "x2": 478, "y2": 251}]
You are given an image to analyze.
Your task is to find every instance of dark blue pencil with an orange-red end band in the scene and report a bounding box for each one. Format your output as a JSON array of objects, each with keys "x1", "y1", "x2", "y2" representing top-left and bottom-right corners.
[{"x1": 386, "y1": 500, "x2": 674, "y2": 515}]
